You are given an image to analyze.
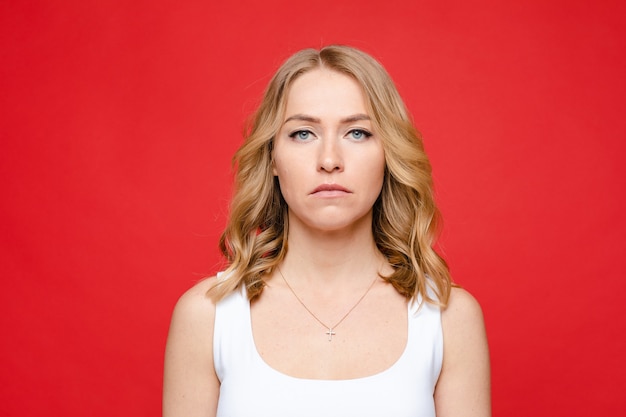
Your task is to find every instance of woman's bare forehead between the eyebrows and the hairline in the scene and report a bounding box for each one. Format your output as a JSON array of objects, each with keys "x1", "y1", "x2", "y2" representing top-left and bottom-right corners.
[{"x1": 285, "y1": 68, "x2": 368, "y2": 117}]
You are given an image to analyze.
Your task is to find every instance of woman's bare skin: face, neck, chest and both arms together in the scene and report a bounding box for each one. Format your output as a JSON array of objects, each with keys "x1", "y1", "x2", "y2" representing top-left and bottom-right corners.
[{"x1": 163, "y1": 69, "x2": 490, "y2": 417}]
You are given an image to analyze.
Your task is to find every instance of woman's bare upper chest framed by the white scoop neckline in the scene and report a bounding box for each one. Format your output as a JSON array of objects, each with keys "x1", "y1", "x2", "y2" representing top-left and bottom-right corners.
[{"x1": 250, "y1": 286, "x2": 409, "y2": 380}]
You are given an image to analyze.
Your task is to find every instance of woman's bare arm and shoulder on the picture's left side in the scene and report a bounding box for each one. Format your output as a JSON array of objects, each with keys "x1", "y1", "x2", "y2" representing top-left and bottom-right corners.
[{"x1": 163, "y1": 279, "x2": 219, "y2": 417}]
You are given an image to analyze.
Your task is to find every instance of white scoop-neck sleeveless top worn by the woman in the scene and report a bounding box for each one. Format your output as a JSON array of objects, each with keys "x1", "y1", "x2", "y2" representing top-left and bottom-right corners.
[{"x1": 213, "y1": 289, "x2": 443, "y2": 417}]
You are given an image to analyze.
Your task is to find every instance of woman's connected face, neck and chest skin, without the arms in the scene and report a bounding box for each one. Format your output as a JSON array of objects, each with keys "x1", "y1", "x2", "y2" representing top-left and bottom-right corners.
[{"x1": 252, "y1": 70, "x2": 407, "y2": 379}]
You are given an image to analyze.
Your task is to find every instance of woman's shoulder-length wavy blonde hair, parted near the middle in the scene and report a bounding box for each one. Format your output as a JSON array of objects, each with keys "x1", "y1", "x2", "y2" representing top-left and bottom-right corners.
[{"x1": 210, "y1": 45, "x2": 451, "y2": 306}]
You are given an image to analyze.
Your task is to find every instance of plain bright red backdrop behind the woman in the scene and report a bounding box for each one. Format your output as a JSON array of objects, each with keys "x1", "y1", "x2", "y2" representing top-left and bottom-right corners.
[{"x1": 0, "y1": 0, "x2": 626, "y2": 416}]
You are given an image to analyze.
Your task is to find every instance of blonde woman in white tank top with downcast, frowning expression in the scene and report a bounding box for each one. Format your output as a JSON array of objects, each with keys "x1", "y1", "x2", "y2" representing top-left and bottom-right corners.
[{"x1": 163, "y1": 46, "x2": 490, "y2": 417}]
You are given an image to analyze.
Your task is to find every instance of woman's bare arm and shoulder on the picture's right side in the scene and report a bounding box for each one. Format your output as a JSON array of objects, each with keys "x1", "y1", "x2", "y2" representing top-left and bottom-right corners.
[{"x1": 435, "y1": 288, "x2": 491, "y2": 417}]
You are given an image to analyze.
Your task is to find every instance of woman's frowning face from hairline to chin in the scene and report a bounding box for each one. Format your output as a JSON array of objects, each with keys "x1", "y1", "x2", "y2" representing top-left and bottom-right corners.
[{"x1": 273, "y1": 69, "x2": 385, "y2": 231}]
